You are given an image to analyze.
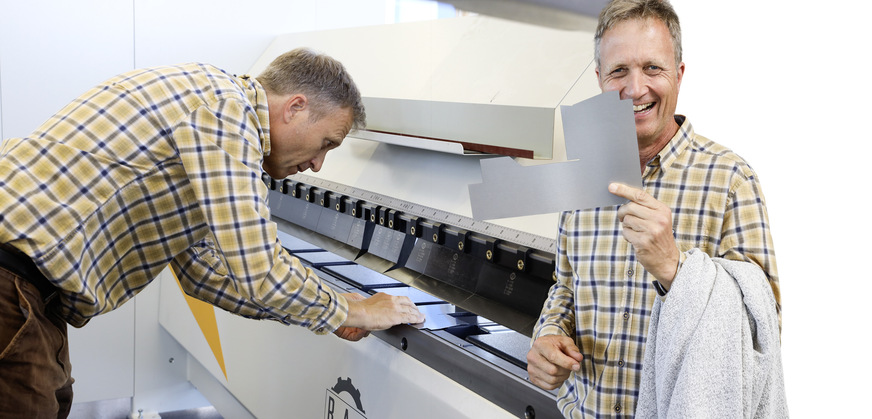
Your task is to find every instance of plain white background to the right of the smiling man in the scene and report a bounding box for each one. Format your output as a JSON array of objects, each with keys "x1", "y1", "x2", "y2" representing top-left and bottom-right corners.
[{"x1": 673, "y1": 0, "x2": 872, "y2": 418}]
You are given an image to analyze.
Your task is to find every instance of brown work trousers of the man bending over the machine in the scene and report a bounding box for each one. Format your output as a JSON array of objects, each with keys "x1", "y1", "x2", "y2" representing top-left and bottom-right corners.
[{"x1": 0, "y1": 267, "x2": 73, "y2": 419}]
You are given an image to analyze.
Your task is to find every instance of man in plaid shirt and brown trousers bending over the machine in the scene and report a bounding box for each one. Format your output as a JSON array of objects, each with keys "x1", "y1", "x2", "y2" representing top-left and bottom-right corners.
[{"x1": 0, "y1": 49, "x2": 424, "y2": 418}]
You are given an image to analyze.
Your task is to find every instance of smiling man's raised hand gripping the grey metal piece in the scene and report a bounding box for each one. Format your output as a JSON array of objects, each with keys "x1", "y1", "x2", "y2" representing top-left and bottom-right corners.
[{"x1": 609, "y1": 183, "x2": 681, "y2": 289}]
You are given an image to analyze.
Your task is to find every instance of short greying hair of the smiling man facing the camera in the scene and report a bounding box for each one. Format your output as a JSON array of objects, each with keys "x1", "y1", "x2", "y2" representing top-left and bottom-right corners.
[{"x1": 593, "y1": 0, "x2": 681, "y2": 67}]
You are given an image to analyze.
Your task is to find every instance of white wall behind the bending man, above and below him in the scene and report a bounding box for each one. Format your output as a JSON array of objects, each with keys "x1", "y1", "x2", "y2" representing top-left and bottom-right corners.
[{"x1": 0, "y1": 0, "x2": 430, "y2": 412}]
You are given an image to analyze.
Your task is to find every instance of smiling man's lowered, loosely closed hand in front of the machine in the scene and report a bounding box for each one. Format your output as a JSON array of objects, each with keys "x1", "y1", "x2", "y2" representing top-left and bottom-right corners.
[{"x1": 527, "y1": 335, "x2": 584, "y2": 390}]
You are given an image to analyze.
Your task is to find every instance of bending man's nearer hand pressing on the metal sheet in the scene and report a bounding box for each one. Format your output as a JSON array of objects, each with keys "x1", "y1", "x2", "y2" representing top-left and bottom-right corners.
[{"x1": 340, "y1": 292, "x2": 424, "y2": 337}]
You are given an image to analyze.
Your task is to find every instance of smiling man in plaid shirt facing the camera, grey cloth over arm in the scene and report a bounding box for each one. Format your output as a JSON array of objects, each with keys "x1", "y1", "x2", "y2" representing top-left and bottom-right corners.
[{"x1": 527, "y1": 0, "x2": 780, "y2": 418}]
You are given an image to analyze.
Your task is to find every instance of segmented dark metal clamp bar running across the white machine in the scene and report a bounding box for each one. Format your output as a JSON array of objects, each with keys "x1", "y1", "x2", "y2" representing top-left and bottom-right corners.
[{"x1": 263, "y1": 174, "x2": 555, "y2": 334}]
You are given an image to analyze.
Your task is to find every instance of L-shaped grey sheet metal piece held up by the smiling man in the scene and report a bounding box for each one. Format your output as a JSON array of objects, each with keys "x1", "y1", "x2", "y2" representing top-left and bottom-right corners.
[{"x1": 469, "y1": 92, "x2": 642, "y2": 220}]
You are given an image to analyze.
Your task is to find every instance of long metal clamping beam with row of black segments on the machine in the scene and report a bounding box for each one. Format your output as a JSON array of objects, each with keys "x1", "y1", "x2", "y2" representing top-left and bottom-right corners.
[{"x1": 263, "y1": 174, "x2": 555, "y2": 337}]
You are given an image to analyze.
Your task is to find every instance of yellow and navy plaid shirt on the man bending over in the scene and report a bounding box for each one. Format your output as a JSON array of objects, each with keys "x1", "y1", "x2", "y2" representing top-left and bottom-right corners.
[{"x1": 0, "y1": 64, "x2": 347, "y2": 333}]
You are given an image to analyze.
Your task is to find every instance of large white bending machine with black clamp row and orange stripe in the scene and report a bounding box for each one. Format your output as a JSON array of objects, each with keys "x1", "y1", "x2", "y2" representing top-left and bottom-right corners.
[{"x1": 160, "y1": 16, "x2": 599, "y2": 419}]
